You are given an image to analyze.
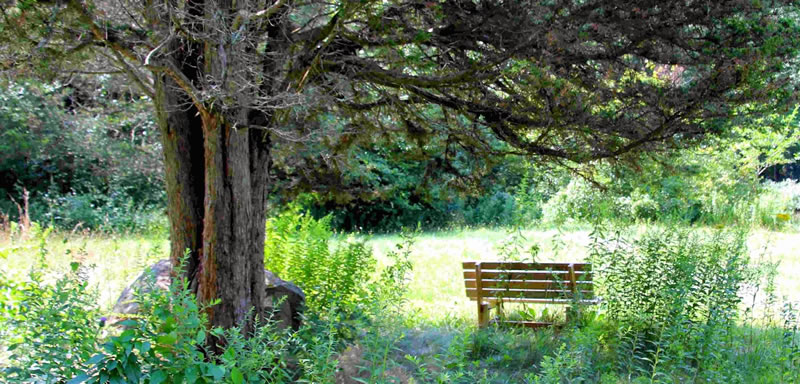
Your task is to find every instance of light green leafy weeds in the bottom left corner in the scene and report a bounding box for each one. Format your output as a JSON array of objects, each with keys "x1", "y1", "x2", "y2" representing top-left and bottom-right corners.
[{"x1": 0, "y1": 255, "x2": 101, "y2": 383}]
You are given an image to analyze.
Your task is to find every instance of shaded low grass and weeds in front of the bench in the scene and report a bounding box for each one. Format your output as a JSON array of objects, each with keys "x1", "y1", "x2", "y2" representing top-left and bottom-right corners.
[{"x1": 337, "y1": 313, "x2": 800, "y2": 383}]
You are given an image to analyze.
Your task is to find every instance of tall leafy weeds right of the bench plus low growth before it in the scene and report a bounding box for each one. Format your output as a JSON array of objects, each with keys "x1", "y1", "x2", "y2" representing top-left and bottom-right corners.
[{"x1": 340, "y1": 228, "x2": 800, "y2": 383}]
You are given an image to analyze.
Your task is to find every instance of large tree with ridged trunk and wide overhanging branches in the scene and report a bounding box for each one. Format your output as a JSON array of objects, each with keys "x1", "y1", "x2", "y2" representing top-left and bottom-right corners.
[{"x1": 0, "y1": 0, "x2": 800, "y2": 326}]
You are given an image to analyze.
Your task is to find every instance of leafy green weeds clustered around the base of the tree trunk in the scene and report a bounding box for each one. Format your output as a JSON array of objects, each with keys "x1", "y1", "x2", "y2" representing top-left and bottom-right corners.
[{"x1": 0, "y1": 212, "x2": 413, "y2": 384}]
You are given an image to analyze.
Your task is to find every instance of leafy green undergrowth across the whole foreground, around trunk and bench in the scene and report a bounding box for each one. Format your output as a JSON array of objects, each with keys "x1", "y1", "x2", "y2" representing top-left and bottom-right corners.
[{"x1": 0, "y1": 211, "x2": 800, "y2": 384}]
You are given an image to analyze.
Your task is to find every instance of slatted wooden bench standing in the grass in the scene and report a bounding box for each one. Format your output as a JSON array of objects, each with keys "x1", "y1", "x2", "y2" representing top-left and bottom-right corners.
[{"x1": 463, "y1": 261, "x2": 597, "y2": 328}]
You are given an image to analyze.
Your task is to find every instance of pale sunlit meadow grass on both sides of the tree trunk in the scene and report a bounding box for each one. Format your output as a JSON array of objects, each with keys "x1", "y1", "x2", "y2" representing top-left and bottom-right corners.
[{"x1": 0, "y1": 226, "x2": 800, "y2": 320}]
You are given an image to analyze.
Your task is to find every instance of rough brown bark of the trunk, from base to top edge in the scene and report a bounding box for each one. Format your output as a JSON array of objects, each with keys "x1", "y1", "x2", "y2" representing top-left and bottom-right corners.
[{"x1": 142, "y1": 1, "x2": 282, "y2": 329}]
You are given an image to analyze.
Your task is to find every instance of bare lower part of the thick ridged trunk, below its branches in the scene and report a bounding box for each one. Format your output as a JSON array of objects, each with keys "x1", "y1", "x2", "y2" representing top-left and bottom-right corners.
[{"x1": 154, "y1": 76, "x2": 270, "y2": 329}]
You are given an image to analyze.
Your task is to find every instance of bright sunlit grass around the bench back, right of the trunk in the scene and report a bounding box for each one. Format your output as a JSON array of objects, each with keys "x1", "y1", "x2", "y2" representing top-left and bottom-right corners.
[{"x1": 369, "y1": 226, "x2": 800, "y2": 319}]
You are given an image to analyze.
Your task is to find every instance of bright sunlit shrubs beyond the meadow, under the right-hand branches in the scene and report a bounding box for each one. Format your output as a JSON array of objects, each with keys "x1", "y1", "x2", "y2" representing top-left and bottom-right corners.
[{"x1": 532, "y1": 110, "x2": 800, "y2": 229}]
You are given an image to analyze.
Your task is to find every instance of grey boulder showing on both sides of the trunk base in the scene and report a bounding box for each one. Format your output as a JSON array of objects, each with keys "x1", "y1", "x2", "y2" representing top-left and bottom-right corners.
[{"x1": 111, "y1": 260, "x2": 306, "y2": 329}]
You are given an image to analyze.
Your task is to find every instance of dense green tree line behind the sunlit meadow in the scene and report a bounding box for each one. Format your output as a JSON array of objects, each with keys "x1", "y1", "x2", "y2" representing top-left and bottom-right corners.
[{"x1": 0, "y1": 75, "x2": 800, "y2": 233}]
